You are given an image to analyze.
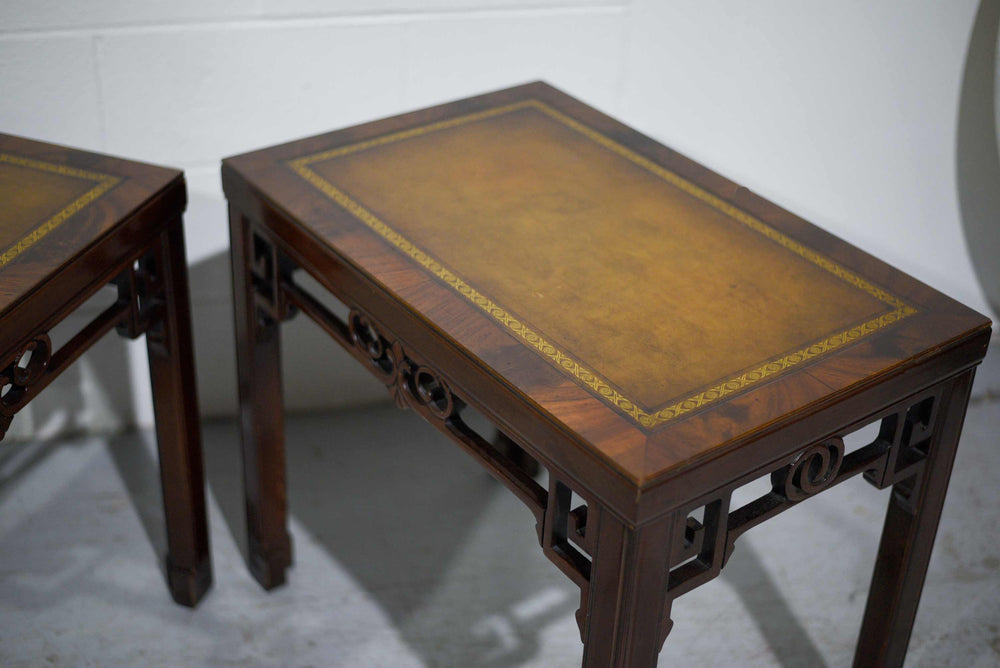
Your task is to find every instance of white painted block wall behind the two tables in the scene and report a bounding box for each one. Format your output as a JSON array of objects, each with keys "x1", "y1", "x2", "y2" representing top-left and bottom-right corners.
[{"x1": 0, "y1": 0, "x2": 987, "y2": 431}]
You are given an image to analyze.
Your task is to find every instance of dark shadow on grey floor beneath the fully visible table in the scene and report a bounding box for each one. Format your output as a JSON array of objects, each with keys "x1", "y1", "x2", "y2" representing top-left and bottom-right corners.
[{"x1": 205, "y1": 406, "x2": 582, "y2": 668}]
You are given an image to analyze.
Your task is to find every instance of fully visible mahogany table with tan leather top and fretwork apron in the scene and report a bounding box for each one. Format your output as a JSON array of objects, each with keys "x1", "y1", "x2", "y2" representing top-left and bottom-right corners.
[{"x1": 222, "y1": 83, "x2": 990, "y2": 668}]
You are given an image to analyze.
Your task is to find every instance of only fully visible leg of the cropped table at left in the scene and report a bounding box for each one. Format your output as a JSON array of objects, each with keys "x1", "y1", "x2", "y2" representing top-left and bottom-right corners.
[{"x1": 146, "y1": 218, "x2": 212, "y2": 606}]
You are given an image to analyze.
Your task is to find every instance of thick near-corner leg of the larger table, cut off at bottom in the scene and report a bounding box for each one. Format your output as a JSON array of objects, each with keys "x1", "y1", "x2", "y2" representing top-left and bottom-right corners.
[{"x1": 583, "y1": 509, "x2": 673, "y2": 668}]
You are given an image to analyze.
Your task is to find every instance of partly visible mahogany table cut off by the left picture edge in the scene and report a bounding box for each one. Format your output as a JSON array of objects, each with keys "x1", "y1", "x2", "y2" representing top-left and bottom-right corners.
[{"x1": 0, "y1": 135, "x2": 212, "y2": 606}]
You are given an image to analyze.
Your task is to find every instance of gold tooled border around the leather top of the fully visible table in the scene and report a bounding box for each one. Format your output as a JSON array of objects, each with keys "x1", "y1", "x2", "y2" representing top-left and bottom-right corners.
[{"x1": 288, "y1": 100, "x2": 917, "y2": 428}]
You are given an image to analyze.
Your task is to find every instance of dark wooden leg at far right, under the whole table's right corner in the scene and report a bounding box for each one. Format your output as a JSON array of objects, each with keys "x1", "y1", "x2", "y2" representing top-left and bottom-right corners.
[{"x1": 854, "y1": 370, "x2": 974, "y2": 668}]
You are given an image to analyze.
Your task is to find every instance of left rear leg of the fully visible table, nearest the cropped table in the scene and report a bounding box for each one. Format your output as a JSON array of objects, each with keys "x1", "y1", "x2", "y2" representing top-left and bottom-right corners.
[{"x1": 230, "y1": 211, "x2": 291, "y2": 589}]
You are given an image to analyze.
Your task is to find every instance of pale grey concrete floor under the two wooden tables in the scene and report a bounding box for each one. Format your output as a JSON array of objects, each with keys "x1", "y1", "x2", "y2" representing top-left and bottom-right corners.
[{"x1": 0, "y1": 400, "x2": 1000, "y2": 668}]
